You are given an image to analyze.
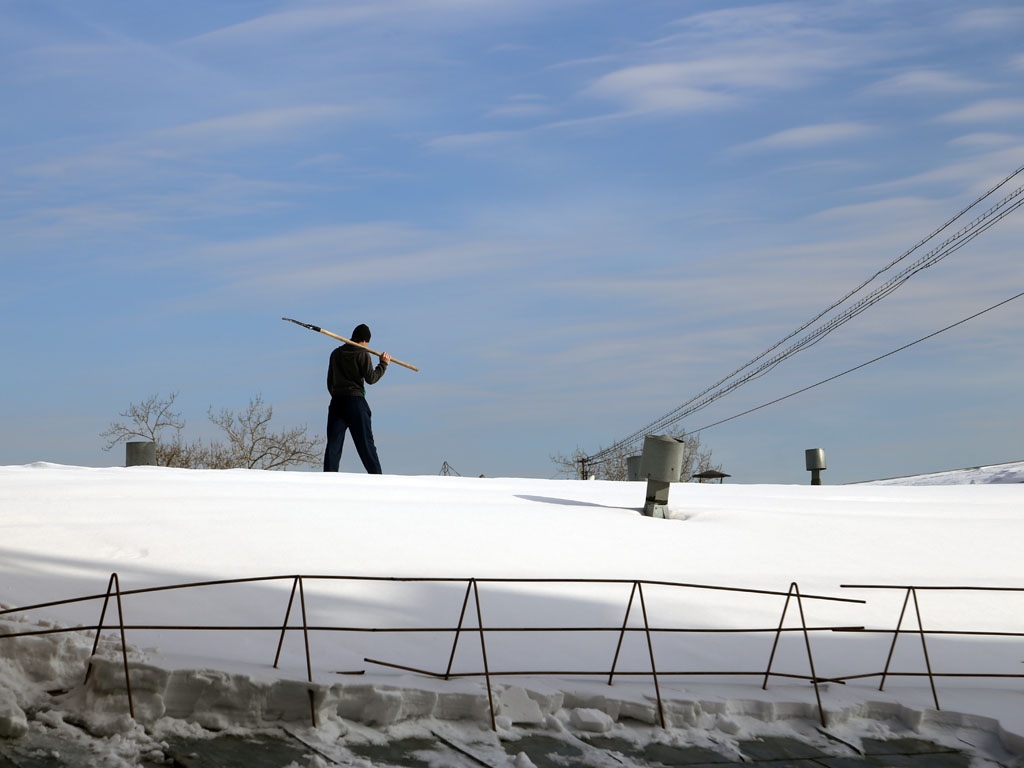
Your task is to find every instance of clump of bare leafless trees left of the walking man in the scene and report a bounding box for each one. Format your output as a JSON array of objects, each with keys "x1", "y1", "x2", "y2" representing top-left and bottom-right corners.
[{"x1": 100, "y1": 393, "x2": 322, "y2": 469}]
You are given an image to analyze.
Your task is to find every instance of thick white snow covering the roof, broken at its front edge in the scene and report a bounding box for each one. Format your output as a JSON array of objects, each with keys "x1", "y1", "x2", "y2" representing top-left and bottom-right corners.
[{"x1": 0, "y1": 462, "x2": 1024, "y2": 765}]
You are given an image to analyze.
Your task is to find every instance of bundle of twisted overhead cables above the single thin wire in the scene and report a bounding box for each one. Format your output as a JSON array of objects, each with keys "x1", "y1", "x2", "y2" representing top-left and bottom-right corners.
[{"x1": 585, "y1": 166, "x2": 1024, "y2": 464}]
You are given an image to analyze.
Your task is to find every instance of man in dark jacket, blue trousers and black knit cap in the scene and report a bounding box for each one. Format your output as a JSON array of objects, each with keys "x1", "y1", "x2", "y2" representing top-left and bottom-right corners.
[{"x1": 324, "y1": 324, "x2": 391, "y2": 475}]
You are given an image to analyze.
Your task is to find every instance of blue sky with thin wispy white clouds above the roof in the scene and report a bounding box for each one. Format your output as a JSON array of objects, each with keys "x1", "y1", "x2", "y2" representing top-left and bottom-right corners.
[{"x1": 0, "y1": 0, "x2": 1024, "y2": 483}]
